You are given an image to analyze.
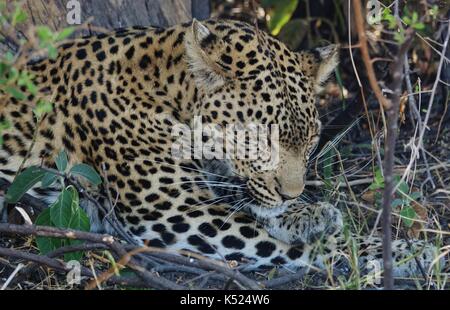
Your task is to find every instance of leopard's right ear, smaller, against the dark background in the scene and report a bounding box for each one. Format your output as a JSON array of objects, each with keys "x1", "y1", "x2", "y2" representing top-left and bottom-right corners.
[{"x1": 300, "y1": 44, "x2": 339, "y2": 93}]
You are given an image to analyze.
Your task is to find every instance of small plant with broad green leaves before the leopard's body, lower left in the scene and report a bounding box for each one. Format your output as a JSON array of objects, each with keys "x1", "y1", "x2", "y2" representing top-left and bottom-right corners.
[{"x1": 5, "y1": 151, "x2": 102, "y2": 261}]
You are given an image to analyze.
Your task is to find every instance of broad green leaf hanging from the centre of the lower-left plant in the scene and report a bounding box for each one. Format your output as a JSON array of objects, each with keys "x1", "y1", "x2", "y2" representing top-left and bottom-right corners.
[{"x1": 50, "y1": 187, "x2": 79, "y2": 228}]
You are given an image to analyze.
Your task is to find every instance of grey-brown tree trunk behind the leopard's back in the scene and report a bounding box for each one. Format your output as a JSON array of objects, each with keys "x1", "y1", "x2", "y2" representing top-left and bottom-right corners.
[{"x1": 0, "y1": 0, "x2": 210, "y2": 53}]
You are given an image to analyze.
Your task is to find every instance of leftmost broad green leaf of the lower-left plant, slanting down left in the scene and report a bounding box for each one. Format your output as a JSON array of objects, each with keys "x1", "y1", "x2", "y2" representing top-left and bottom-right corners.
[{"x1": 5, "y1": 166, "x2": 46, "y2": 204}]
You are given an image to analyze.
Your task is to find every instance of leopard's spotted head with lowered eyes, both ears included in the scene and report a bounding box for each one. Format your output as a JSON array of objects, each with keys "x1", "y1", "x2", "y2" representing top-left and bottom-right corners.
[{"x1": 186, "y1": 20, "x2": 338, "y2": 217}]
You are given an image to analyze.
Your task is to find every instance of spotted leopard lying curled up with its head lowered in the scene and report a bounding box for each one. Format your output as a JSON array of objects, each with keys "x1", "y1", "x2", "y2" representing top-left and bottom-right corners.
[{"x1": 0, "y1": 19, "x2": 438, "y2": 277}]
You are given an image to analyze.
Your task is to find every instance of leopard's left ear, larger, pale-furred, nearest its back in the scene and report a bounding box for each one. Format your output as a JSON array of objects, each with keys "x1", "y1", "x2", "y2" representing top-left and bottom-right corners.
[{"x1": 186, "y1": 19, "x2": 232, "y2": 92}]
